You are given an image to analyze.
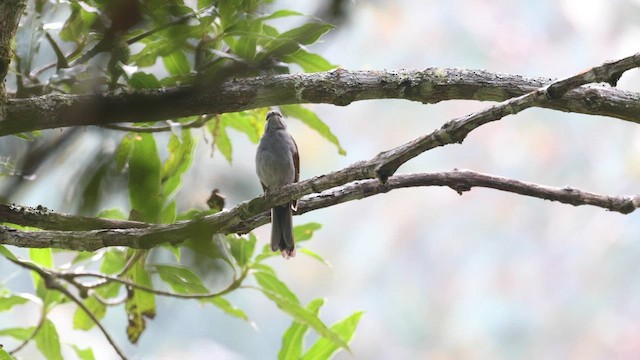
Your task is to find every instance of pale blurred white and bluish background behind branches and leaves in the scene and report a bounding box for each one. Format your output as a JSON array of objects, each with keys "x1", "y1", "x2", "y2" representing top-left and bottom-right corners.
[{"x1": 0, "y1": 0, "x2": 640, "y2": 359}]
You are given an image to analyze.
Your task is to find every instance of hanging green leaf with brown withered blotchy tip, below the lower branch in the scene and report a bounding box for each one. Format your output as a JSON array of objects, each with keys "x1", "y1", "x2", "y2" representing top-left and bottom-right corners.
[{"x1": 125, "y1": 256, "x2": 156, "y2": 344}]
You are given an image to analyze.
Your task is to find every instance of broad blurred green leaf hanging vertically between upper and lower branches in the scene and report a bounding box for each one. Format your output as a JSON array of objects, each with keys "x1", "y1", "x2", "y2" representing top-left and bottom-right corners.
[{"x1": 129, "y1": 134, "x2": 163, "y2": 223}]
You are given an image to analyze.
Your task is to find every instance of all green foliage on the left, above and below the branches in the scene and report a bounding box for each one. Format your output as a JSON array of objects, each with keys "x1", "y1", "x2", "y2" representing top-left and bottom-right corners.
[{"x1": 0, "y1": 0, "x2": 361, "y2": 359}]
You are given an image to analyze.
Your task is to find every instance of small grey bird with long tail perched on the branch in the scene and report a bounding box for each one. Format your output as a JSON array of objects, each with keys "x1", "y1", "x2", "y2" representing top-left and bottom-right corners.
[{"x1": 256, "y1": 110, "x2": 300, "y2": 259}]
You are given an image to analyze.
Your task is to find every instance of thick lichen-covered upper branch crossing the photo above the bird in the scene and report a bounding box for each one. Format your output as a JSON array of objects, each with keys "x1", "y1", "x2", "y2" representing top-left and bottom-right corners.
[{"x1": 5, "y1": 55, "x2": 640, "y2": 136}]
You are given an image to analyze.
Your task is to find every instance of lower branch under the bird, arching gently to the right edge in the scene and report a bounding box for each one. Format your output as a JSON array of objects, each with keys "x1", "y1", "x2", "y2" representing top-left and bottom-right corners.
[{"x1": 0, "y1": 170, "x2": 640, "y2": 251}]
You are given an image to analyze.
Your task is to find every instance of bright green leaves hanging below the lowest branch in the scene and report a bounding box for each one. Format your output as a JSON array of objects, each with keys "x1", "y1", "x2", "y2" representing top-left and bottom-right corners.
[{"x1": 0, "y1": 223, "x2": 362, "y2": 359}]
